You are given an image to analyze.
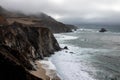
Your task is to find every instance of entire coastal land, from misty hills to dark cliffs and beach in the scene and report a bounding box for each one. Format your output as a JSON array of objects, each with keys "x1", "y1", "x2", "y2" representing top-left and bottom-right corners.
[{"x1": 0, "y1": 6, "x2": 76, "y2": 80}]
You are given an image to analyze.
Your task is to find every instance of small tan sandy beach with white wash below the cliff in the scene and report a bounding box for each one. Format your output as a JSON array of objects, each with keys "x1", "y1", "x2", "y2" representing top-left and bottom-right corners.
[{"x1": 30, "y1": 60, "x2": 61, "y2": 80}]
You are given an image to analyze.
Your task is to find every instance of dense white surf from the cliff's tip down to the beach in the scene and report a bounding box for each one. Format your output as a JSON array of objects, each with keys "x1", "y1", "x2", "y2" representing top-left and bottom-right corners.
[{"x1": 51, "y1": 44, "x2": 95, "y2": 80}]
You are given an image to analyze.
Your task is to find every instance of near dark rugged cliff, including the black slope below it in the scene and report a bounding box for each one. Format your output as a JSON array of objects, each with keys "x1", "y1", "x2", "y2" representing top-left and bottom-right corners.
[{"x1": 0, "y1": 22, "x2": 60, "y2": 80}]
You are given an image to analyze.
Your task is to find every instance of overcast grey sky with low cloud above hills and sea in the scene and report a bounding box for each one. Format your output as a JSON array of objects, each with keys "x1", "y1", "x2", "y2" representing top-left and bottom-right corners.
[{"x1": 0, "y1": 0, "x2": 120, "y2": 24}]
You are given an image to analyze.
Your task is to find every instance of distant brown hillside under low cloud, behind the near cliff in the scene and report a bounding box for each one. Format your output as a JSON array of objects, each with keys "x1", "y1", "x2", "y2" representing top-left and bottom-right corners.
[{"x1": 0, "y1": 7, "x2": 77, "y2": 33}]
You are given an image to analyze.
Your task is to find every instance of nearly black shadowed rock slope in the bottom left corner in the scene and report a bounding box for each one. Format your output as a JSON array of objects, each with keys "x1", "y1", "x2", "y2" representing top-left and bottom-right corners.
[{"x1": 0, "y1": 45, "x2": 42, "y2": 80}]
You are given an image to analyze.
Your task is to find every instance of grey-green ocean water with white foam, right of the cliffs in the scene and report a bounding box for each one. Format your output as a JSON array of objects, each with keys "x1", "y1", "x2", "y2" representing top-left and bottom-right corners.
[{"x1": 50, "y1": 28, "x2": 120, "y2": 80}]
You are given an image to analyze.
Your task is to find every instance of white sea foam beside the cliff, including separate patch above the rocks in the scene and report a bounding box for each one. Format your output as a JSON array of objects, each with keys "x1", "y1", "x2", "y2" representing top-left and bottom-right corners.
[{"x1": 51, "y1": 34, "x2": 112, "y2": 80}]
